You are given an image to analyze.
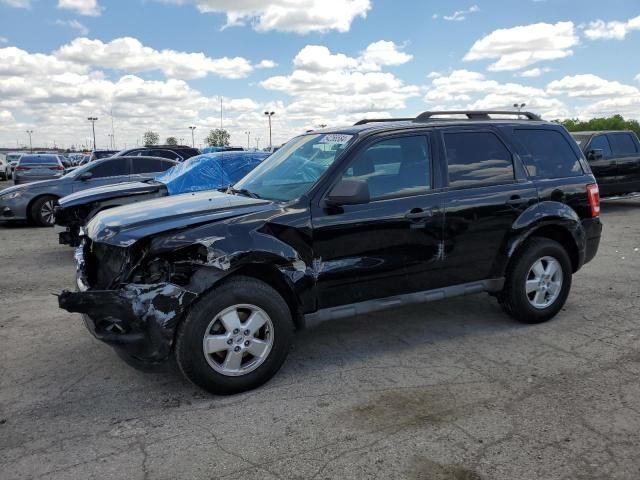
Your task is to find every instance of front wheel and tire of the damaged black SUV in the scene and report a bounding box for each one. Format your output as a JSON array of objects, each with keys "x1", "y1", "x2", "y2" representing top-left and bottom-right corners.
[{"x1": 175, "y1": 277, "x2": 294, "y2": 395}]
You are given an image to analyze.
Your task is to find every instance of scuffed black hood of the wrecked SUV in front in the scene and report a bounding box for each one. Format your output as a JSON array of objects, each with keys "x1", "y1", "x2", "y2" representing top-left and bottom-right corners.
[{"x1": 85, "y1": 191, "x2": 274, "y2": 247}]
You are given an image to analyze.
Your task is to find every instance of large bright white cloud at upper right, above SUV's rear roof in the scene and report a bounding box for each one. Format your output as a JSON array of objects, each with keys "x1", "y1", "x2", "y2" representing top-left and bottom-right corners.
[{"x1": 464, "y1": 22, "x2": 579, "y2": 71}]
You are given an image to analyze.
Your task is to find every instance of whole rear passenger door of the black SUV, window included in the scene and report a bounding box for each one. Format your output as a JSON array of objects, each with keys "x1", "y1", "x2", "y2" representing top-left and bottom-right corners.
[{"x1": 441, "y1": 127, "x2": 538, "y2": 285}]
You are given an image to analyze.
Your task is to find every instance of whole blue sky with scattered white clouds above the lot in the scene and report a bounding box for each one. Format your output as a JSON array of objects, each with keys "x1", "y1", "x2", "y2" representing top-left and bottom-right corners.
[{"x1": 0, "y1": 0, "x2": 640, "y2": 147}]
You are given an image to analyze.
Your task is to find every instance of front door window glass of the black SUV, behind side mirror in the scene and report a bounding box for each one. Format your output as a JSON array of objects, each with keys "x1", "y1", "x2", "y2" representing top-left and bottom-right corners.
[{"x1": 342, "y1": 136, "x2": 431, "y2": 200}]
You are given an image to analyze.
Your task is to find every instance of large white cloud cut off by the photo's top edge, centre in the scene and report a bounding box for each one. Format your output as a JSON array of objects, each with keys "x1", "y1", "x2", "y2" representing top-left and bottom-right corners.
[{"x1": 160, "y1": 0, "x2": 371, "y2": 34}]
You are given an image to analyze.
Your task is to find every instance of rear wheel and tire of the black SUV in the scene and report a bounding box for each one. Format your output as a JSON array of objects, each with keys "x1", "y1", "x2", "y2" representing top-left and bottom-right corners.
[{"x1": 498, "y1": 237, "x2": 572, "y2": 324}]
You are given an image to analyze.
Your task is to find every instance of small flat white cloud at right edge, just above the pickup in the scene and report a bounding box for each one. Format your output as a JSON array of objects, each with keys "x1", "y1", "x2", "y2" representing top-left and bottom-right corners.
[{"x1": 547, "y1": 74, "x2": 640, "y2": 98}]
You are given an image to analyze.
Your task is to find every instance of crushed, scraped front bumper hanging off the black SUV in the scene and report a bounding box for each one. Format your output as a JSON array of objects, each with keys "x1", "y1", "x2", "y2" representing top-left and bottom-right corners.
[{"x1": 58, "y1": 283, "x2": 197, "y2": 363}]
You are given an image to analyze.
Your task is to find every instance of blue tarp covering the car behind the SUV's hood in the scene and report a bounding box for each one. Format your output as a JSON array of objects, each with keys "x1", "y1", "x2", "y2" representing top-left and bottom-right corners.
[{"x1": 155, "y1": 152, "x2": 269, "y2": 195}]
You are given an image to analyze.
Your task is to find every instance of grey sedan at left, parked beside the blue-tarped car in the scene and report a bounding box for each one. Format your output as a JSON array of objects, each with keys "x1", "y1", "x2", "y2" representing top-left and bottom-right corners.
[{"x1": 0, "y1": 156, "x2": 177, "y2": 226}]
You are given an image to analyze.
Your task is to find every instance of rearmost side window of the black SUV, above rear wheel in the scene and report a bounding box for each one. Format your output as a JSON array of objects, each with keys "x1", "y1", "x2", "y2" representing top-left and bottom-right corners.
[{"x1": 514, "y1": 129, "x2": 584, "y2": 178}]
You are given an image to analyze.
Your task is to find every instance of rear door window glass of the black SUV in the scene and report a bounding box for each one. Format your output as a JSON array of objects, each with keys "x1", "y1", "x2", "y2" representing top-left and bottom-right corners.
[{"x1": 444, "y1": 132, "x2": 515, "y2": 188}]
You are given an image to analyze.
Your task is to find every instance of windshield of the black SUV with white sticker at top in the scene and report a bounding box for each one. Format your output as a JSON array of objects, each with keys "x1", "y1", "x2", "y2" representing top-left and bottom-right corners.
[{"x1": 233, "y1": 133, "x2": 354, "y2": 202}]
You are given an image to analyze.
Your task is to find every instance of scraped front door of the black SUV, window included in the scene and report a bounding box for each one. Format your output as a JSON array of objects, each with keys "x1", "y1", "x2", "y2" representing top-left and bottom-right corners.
[{"x1": 312, "y1": 134, "x2": 443, "y2": 308}]
